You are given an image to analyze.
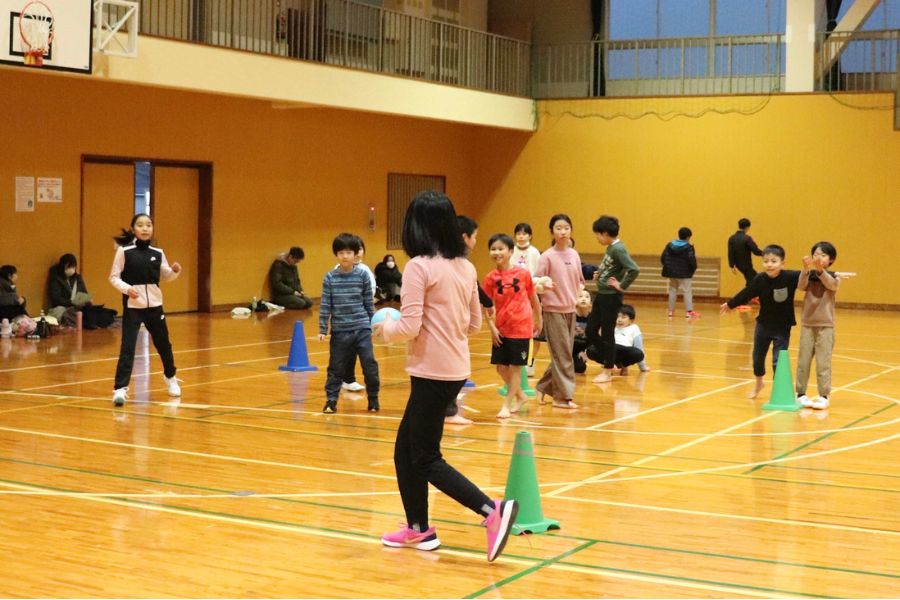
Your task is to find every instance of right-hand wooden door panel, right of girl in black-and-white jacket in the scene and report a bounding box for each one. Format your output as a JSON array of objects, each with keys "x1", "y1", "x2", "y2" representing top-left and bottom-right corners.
[{"x1": 152, "y1": 166, "x2": 200, "y2": 313}]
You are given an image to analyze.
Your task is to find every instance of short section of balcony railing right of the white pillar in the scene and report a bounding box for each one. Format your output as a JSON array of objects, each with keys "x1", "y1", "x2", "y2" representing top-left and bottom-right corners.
[{"x1": 816, "y1": 29, "x2": 900, "y2": 91}]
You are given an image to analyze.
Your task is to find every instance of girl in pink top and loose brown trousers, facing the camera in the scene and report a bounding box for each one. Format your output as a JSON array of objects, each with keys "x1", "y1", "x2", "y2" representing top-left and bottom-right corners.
[{"x1": 534, "y1": 214, "x2": 584, "y2": 408}]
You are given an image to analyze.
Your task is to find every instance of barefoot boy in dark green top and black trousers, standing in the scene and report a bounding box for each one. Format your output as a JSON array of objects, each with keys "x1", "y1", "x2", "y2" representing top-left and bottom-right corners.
[{"x1": 585, "y1": 215, "x2": 641, "y2": 383}]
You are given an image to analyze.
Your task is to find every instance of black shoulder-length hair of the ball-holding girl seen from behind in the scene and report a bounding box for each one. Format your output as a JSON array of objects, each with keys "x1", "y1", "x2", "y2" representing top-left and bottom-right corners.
[{"x1": 403, "y1": 190, "x2": 466, "y2": 258}]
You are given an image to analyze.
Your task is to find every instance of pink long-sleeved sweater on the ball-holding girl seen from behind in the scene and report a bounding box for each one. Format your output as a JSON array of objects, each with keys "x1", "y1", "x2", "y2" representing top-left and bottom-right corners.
[{"x1": 382, "y1": 256, "x2": 481, "y2": 381}]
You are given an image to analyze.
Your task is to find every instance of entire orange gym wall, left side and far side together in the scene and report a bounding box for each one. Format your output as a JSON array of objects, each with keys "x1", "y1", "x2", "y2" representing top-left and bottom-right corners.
[{"x1": 0, "y1": 68, "x2": 900, "y2": 307}]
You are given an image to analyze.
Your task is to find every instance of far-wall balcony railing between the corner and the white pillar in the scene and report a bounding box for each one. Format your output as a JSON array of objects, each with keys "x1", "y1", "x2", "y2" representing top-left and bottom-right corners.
[{"x1": 531, "y1": 35, "x2": 785, "y2": 98}]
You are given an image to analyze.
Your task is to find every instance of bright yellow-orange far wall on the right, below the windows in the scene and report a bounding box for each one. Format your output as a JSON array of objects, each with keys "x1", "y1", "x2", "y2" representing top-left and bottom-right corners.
[{"x1": 473, "y1": 94, "x2": 900, "y2": 305}]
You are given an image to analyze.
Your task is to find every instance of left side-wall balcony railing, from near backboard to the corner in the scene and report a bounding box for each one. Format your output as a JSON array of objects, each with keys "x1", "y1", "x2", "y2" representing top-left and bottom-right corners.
[{"x1": 96, "y1": 0, "x2": 531, "y2": 96}]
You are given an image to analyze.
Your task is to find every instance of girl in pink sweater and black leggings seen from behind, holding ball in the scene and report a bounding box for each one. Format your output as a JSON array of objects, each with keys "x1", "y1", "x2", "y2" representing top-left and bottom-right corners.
[{"x1": 372, "y1": 191, "x2": 519, "y2": 561}]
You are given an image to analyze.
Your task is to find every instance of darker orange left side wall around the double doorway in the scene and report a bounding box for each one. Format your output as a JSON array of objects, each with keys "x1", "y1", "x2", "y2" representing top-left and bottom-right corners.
[{"x1": 0, "y1": 68, "x2": 482, "y2": 310}]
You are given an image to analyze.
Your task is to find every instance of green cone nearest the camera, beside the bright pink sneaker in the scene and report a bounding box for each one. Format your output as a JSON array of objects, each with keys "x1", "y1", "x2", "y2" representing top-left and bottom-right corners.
[{"x1": 503, "y1": 431, "x2": 559, "y2": 535}]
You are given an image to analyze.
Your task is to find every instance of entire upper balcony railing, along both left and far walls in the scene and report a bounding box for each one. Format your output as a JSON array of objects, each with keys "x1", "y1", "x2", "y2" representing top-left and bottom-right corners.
[{"x1": 95, "y1": 0, "x2": 900, "y2": 98}]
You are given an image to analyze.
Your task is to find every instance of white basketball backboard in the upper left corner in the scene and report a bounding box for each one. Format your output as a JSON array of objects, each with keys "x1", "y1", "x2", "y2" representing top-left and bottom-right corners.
[{"x1": 0, "y1": 0, "x2": 94, "y2": 73}]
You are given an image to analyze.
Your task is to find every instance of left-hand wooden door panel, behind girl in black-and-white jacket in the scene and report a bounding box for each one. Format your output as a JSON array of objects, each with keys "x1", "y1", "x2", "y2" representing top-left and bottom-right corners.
[{"x1": 79, "y1": 162, "x2": 134, "y2": 314}]
